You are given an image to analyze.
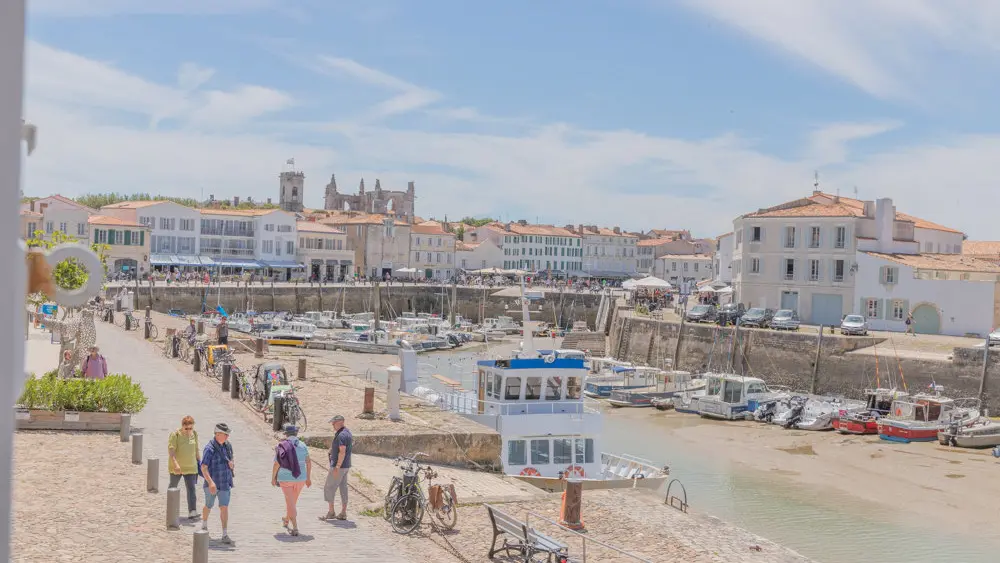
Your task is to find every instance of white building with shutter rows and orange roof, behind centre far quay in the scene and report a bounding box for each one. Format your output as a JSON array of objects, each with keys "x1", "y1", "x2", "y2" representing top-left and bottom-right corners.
[{"x1": 476, "y1": 221, "x2": 583, "y2": 276}]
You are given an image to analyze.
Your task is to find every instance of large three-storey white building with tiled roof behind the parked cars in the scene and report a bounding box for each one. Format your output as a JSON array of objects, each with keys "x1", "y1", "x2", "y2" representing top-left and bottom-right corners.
[{"x1": 732, "y1": 191, "x2": 964, "y2": 325}]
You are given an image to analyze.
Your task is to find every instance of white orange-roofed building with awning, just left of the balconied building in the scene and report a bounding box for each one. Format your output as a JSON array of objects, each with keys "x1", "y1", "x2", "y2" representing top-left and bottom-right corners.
[{"x1": 101, "y1": 201, "x2": 203, "y2": 271}]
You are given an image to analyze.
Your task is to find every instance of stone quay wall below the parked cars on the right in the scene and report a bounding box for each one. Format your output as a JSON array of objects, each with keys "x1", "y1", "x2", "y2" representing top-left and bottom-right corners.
[{"x1": 608, "y1": 308, "x2": 1000, "y2": 413}]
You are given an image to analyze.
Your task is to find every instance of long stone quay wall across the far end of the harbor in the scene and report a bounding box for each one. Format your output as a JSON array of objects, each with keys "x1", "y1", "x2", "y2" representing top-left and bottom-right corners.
[{"x1": 106, "y1": 284, "x2": 601, "y2": 328}]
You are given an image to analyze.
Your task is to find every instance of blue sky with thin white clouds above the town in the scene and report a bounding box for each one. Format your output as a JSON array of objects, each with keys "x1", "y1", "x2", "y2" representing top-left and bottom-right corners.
[{"x1": 24, "y1": 0, "x2": 1000, "y2": 240}]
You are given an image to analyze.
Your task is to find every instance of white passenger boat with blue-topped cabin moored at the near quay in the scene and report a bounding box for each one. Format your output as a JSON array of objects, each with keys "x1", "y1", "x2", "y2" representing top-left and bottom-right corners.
[{"x1": 439, "y1": 282, "x2": 669, "y2": 490}]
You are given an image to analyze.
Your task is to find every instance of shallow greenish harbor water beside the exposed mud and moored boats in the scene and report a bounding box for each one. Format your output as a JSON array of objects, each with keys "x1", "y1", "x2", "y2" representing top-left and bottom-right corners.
[{"x1": 404, "y1": 342, "x2": 1000, "y2": 563}]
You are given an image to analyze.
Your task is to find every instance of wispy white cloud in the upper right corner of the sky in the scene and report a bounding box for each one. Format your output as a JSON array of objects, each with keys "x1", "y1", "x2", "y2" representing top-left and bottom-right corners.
[{"x1": 685, "y1": 0, "x2": 1000, "y2": 102}]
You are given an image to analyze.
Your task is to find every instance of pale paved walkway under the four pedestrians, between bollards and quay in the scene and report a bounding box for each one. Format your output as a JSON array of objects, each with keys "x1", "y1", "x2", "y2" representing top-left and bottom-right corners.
[{"x1": 98, "y1": 323, "x2": 432, "y2": 562}]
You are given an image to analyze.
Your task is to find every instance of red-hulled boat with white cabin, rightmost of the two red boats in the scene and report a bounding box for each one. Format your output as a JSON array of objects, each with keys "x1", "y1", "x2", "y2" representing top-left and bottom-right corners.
[{"x1": 877, "y1": 394, "x2": 982, "y2": 443}]
